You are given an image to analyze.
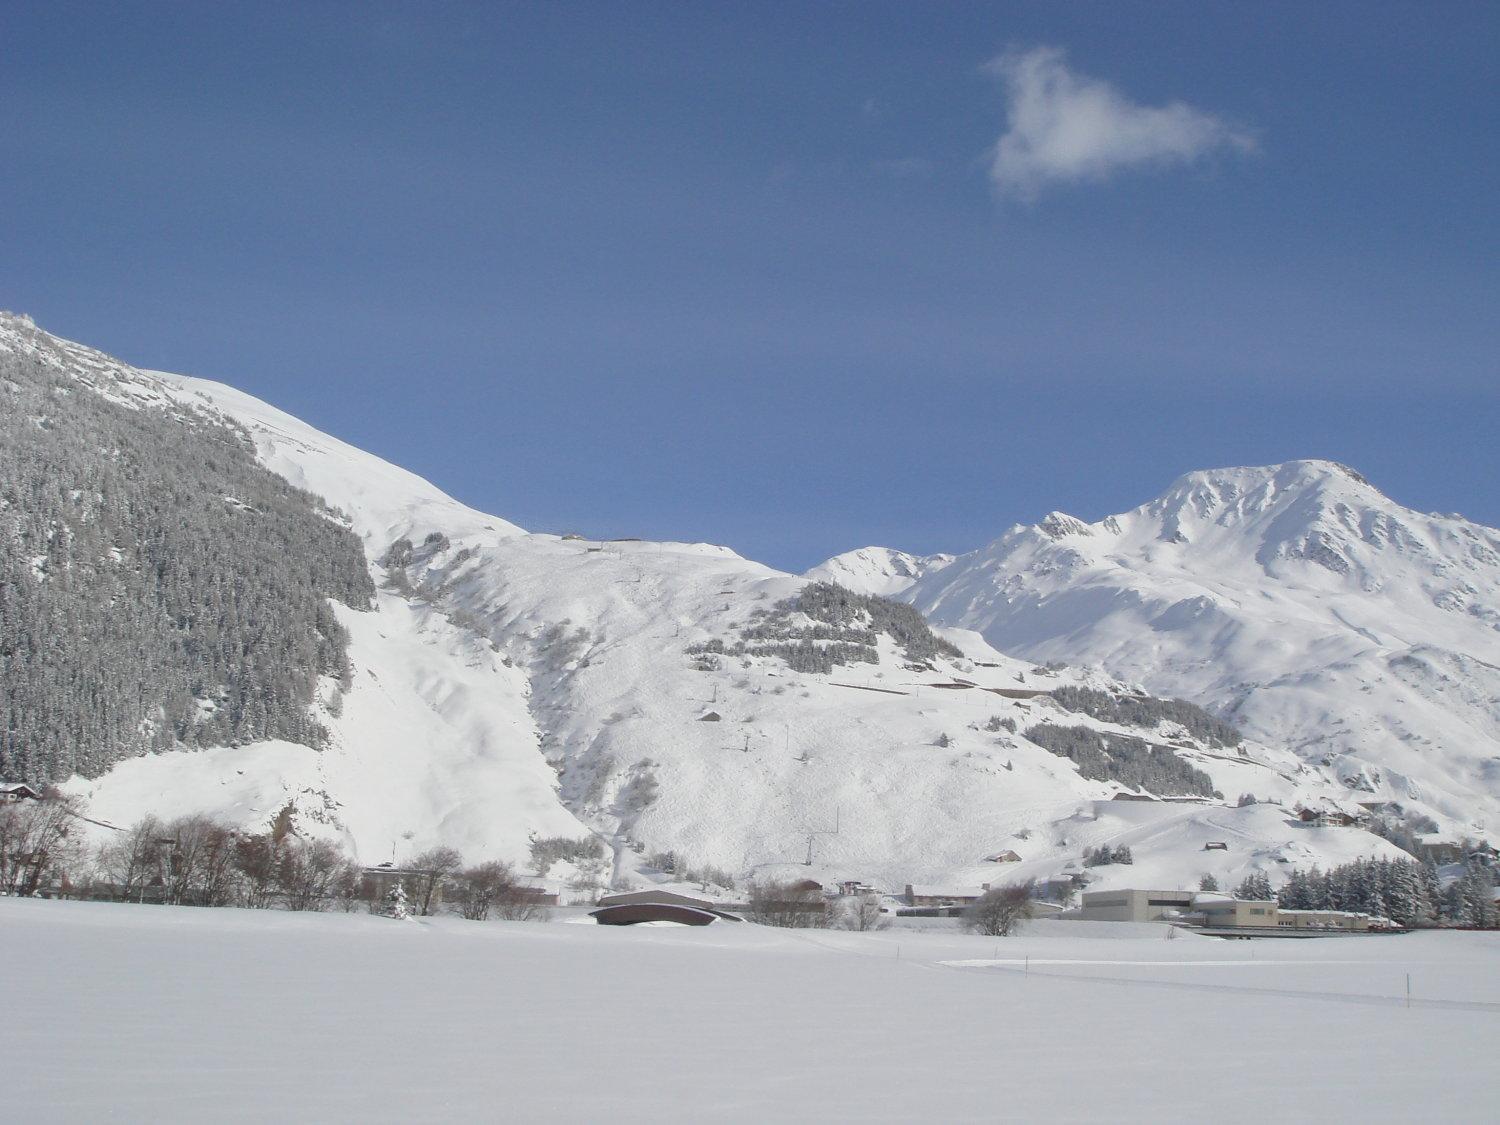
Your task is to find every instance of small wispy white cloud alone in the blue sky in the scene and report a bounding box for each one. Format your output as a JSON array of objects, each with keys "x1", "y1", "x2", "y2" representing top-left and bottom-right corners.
[{"x1": 989, "y1": 47, "x2": 1256, "y2": 200}]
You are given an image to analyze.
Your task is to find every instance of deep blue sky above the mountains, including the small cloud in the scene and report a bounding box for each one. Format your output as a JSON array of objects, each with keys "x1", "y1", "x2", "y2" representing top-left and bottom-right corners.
[{"x1": 0, "y1": 3, "x2": 1500, "y2": 569}]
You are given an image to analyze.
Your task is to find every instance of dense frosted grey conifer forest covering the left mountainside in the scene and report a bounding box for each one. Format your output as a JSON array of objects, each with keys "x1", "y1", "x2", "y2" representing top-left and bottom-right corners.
[{"x1": 0, "y1": 323, "x2": 374, "y2": 782}]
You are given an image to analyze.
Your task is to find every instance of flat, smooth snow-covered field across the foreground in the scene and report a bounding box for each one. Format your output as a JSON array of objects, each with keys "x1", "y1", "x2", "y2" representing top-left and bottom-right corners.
[{"x1": 0, "y1": 899, "x2": 1500, "y2": 1122}]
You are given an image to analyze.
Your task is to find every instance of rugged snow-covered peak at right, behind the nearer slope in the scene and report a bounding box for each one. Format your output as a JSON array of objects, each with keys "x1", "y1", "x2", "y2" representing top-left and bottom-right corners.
[{"x1": 900, "y1": 461, "x2": 1500, "y2": 836}]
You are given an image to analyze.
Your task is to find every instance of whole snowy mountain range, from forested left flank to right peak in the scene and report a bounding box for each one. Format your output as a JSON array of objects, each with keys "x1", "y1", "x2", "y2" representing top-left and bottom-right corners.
[{"x1": 0, "y1": 317, "x2": 1482, "y2": 887}]
